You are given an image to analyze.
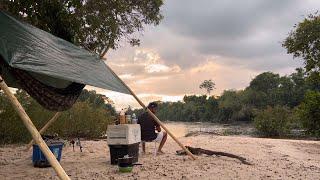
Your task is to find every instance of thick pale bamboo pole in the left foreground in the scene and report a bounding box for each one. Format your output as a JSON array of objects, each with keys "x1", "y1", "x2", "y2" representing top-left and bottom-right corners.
[{"x1": 0, "y1": 76, "x2": 70, "y2": 180}]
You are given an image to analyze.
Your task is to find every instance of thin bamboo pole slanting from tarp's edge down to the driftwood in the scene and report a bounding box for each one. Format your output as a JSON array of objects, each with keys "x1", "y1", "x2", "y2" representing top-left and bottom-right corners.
[{"x1": 100, "y1": 59, "x2": 196, "y2": 160}]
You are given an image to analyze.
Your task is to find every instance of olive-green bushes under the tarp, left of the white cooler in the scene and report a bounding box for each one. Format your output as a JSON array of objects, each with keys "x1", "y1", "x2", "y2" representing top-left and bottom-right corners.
[{"x1": 0, "y1": 90, "x2": 115, "y2": 144}]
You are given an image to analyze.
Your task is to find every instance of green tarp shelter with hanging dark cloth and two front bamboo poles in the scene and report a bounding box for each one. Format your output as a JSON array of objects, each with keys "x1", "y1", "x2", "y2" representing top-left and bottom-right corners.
[{"x1": 0, "y1": 11, "x2": 195, "y2": 179}]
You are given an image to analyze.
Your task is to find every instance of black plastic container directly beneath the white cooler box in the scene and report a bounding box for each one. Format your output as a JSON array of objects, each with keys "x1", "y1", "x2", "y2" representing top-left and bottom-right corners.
[{"x1": 109, "y1": 143, "x2": 139, "y2": 165}]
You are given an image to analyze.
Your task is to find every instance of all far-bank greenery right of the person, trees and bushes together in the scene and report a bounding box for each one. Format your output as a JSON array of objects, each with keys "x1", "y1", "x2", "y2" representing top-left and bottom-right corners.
[{"x1": 135, "y1": 68, "x2": 320, "y2": 136}]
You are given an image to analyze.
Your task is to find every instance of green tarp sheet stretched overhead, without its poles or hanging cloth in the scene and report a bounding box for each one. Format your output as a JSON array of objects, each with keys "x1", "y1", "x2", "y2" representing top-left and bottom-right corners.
[{"x1": 0, "y1": 11, "x2": 130, "y2": 94}]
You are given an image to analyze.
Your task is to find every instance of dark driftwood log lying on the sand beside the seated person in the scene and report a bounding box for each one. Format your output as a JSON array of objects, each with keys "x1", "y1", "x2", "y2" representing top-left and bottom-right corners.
[{"x1": 176, "y1": 146, "x2": 252, "y2": 165}]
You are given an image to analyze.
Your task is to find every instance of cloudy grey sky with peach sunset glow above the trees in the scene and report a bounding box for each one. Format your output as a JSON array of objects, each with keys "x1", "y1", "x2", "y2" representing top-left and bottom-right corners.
[{"x1": 87, "y1": 0, "x2": 320, "y2": 109}]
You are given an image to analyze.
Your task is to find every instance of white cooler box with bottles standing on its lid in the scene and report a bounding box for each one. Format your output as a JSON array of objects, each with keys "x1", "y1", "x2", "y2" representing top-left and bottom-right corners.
[{"x1": 107, "y1": 124, "x2": 141, "y2": 145}]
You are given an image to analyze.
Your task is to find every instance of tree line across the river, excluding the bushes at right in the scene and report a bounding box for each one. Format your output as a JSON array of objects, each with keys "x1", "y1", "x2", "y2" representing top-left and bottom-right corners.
[{"x1": 136, "y1": 69, "x2": 310, "y2": 122}]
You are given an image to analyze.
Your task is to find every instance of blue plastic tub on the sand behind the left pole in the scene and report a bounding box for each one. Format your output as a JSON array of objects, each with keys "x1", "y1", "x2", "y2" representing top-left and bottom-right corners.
[{"x1": 32, "y1": 143, "x2": 63, "y2": 167}]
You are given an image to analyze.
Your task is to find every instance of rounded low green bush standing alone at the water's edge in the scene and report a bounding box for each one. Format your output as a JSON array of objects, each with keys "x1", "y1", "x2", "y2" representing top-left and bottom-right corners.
[{"x1": 254, "y1": 106, "x2": 292, "y2": 137}]
